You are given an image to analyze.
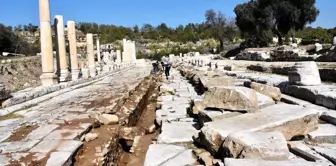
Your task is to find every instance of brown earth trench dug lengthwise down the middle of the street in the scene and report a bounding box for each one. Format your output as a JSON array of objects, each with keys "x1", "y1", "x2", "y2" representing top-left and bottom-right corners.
[{"x1": 74, "y1": 76, "x2": 159, "y2": 166}]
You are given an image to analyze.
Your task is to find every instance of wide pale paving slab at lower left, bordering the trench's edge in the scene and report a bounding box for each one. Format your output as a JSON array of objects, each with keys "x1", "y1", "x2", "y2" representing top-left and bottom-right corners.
[{"x1": 30, "y1": 140, "x2": 83, "y2": 153}]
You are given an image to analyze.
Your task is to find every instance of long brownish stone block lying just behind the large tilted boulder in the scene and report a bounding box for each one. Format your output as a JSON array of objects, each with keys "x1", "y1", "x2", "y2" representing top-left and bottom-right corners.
[{"x1": 244, "y1": 82, "x2": 281, "y2": 101}]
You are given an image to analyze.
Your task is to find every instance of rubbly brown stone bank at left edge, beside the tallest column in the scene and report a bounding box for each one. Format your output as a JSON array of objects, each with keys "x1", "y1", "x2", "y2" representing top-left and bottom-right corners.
[{"x1": 0, "y1": 56, "x2": 42, "y2": 92}]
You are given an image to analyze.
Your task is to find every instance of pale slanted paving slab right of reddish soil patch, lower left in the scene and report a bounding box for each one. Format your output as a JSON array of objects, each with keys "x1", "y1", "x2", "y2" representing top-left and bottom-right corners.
[{"x1": 25, "y1": 125, "x2": 59, "y2": 140}]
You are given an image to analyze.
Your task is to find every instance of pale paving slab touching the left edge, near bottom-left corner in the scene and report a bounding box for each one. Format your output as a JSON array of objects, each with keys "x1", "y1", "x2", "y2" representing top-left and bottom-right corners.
[{"x1": 0, "y1": 140, "x2": 40, "y2": 153}]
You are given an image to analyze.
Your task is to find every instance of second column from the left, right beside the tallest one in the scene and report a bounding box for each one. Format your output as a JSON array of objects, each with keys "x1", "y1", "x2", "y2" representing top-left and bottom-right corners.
[{"x1": 55, "y1": 15, "x2": 71, "y2": 82}]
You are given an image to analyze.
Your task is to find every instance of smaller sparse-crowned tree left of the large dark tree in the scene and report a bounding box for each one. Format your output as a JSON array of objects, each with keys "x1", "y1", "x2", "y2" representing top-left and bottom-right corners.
[{"x1": 205, "y1": 9, "x2": 236, "y2": 49}]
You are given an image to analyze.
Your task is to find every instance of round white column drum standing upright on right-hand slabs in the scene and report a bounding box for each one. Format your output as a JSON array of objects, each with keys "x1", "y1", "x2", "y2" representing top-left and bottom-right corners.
[{"x1": 288, "y1": 61, "x2": 321, "y2": 86}]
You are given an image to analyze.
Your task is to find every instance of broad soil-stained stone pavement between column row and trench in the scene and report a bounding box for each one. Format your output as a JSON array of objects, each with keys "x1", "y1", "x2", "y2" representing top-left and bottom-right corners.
[{"x1": 0, "y1": 67, "x2": 151, "y2": 166}]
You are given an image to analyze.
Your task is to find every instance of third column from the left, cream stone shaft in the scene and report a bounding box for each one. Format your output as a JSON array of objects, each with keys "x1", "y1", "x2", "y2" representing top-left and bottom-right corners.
[{"x1": 67, "y1": 21, "x2": 80, "y2": 80}]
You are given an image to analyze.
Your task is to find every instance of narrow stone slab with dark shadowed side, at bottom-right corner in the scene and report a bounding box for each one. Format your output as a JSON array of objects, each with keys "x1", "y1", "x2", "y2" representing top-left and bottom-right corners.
[{"x1": 288, "y1": 141, "x2": 332, "y2": 165}]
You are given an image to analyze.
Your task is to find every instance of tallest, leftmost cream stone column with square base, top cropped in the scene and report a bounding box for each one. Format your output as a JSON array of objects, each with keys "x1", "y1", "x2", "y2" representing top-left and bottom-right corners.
[{"x1": 39, "y1": 0, "x2": 57, "y2": 86}]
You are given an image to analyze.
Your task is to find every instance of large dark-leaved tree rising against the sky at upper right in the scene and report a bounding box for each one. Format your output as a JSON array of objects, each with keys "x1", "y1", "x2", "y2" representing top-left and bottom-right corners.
[{"x1": 234, "y1": 0, "x2": 319, "y2": 45}]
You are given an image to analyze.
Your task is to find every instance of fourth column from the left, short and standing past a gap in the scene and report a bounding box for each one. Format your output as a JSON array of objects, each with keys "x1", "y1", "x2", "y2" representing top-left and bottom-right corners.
[{"x1": 86, "y1": 33, "x2": 96, "y2": 77}]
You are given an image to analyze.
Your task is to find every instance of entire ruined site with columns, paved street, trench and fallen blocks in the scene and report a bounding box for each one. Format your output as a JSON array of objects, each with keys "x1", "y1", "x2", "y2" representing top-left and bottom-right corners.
[{"x1": 0, "y1": 0, "x2": 336, "y2": 166}]
